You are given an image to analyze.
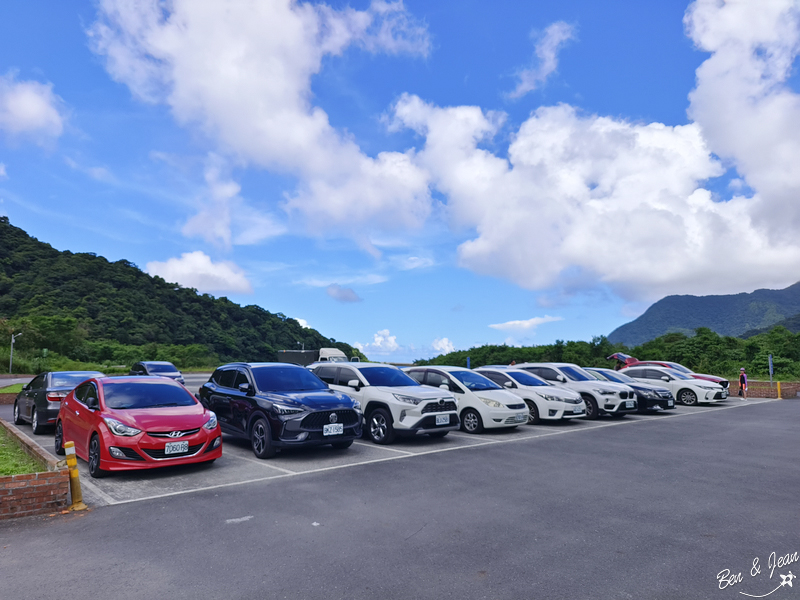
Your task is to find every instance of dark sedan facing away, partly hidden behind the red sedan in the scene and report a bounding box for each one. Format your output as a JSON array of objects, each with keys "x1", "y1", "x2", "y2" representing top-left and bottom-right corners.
[{"x1": 14, "y1": 371, "x2": 104, "y2": 435}]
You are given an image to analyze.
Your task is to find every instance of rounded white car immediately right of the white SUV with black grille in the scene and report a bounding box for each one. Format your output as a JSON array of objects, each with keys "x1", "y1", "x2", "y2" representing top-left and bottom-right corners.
[{"x1": 405, "y1": 366, "x2": 528, "y2": 433}]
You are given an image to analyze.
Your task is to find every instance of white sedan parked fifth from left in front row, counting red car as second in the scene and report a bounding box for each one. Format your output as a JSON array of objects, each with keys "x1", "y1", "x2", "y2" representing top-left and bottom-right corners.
[{"x1": 475, "y1": 366, "x2": 586, "y2": 425}]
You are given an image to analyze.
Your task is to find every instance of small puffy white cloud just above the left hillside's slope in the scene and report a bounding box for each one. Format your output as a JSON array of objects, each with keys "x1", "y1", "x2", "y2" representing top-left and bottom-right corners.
[{"x1": 146, "y1": 250, "x2": 253, "y2": 294}]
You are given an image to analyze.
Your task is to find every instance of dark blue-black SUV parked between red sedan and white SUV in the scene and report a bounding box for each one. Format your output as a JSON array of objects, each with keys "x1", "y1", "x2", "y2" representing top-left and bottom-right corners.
[{"x1": 198, "y1": 363, "x2": 362, "y2": 458}]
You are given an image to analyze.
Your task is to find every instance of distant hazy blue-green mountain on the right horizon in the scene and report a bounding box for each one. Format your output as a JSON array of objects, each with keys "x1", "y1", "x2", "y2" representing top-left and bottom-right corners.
[{"x1": 608, "y1": 282, "x2": 800, "y2": 347}]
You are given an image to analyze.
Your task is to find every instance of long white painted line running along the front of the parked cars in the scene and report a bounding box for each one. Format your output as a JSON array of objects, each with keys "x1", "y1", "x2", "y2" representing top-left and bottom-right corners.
[{"x1": 98, "y1": 399, "x2": 779, "y2": 504}]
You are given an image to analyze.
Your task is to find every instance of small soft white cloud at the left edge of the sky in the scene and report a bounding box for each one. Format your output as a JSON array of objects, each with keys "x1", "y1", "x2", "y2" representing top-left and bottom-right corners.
[{"x1": 0, "y1": 72, "x2": 64, "y2": 144}]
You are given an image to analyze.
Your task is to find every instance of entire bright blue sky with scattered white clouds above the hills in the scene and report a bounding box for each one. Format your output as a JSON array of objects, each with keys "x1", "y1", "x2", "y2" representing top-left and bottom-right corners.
[{"x1": 0, "y1": 0, "x2": 800, "y2": 361}]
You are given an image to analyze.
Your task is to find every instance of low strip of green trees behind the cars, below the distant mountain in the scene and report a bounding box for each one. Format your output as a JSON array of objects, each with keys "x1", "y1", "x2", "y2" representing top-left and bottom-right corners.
[{"x1": 415, "y1": 327, "x2": 800, "y2": 380}]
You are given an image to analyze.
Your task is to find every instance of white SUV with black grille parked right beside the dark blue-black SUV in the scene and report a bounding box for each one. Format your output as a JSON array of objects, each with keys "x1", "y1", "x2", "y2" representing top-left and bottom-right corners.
[{"x1": 308, "y1": 363, "x2": 461, "y2": 444}]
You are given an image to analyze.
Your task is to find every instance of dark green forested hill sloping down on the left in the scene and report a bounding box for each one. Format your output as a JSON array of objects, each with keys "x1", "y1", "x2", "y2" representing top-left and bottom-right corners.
[{"x1": 0, "y1": 217, "x2": 359, "y2": 361}]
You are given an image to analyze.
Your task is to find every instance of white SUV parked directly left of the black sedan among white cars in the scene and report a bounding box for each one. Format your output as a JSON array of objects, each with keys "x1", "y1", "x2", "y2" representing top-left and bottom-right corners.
[{"x1": 516, "y1": 363, "x2": 637, "y2": 419}]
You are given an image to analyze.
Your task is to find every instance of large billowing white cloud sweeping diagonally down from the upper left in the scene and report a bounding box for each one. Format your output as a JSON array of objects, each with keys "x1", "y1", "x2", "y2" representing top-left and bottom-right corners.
[{"x1": 90, "y1": 0, "x2": 431, "y2": 245}]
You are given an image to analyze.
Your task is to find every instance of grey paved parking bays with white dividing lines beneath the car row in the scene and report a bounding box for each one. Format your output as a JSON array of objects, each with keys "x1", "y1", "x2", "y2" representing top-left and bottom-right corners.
[{"x1": 0, "y1": 396, "x2": 774, "y2": 506}]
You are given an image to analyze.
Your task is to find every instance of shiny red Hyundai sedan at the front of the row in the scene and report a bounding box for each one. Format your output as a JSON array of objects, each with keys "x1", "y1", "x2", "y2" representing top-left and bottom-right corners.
[{"x1": 55, "y1": 377, "x2": 222, "y2": 477}]
